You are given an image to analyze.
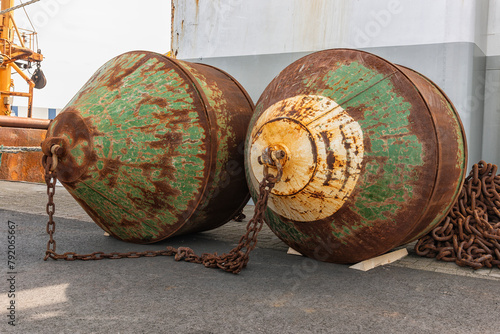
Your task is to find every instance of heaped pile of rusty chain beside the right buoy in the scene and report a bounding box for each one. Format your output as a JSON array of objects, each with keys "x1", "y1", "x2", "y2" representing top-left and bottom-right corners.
[{"x1": 415, "y1": 161, "x2": 500, "y2": 269}]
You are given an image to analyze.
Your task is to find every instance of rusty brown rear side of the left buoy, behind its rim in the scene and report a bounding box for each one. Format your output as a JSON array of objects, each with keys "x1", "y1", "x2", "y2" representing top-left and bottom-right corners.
[{"x1": 177, "y1": 60, "x2": 254, "y2": 233}]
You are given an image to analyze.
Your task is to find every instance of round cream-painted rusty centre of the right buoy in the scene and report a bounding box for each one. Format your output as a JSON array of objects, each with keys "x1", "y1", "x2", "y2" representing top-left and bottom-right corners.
[{"x1": 250, "y1": 95, "x2": 364, "y2": 221}]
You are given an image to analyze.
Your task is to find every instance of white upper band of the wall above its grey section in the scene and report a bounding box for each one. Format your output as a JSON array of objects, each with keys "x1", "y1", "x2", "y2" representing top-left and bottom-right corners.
[{"x1": 172, "y1": 0, "x2": 488, "y2": 58}]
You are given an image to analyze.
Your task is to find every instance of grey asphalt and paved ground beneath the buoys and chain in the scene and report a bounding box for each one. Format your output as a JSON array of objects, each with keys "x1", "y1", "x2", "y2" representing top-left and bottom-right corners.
[{"x1": 0, "y1": 181, "x2": 500, "y2": 334}]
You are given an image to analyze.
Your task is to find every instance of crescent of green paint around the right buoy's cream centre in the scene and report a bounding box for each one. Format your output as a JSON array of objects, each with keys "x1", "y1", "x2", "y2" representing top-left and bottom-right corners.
[{"x1": 305, "y1": 62, "x2": 423, "y2": 234}]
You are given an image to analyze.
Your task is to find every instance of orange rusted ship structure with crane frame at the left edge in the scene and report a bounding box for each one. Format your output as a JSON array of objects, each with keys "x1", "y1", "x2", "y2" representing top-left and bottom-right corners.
[{"x1": 0, "y1": 0, "x2": 46, "y2": 182}]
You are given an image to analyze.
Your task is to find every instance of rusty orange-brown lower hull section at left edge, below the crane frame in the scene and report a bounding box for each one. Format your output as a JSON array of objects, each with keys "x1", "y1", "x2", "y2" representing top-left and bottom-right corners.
[{"x1": 0, "y1": 126, "x2": 47, "y2": 182}]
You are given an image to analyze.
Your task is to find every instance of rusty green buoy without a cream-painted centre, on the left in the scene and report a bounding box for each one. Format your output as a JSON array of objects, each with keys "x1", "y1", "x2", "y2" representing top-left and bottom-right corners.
[{"x1": 42, "y1": 51, "x2": 253, "y2": 243}]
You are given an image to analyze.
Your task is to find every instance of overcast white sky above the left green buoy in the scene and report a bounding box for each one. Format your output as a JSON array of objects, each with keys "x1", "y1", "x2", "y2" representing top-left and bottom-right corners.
[{"x1": 12, "y1": 0, "x2": 171, "y2": 108}]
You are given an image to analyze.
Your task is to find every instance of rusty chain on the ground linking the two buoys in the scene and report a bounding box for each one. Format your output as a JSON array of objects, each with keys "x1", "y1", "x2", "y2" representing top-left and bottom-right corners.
[{"x1": 43, "y1": 145, "x2": 282, "y2": 274}]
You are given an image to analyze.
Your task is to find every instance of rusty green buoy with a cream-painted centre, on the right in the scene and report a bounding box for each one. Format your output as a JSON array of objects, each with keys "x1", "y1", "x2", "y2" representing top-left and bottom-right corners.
[{"x1": 245, "y1": 49, "x2": 466, "y2": 263}]
